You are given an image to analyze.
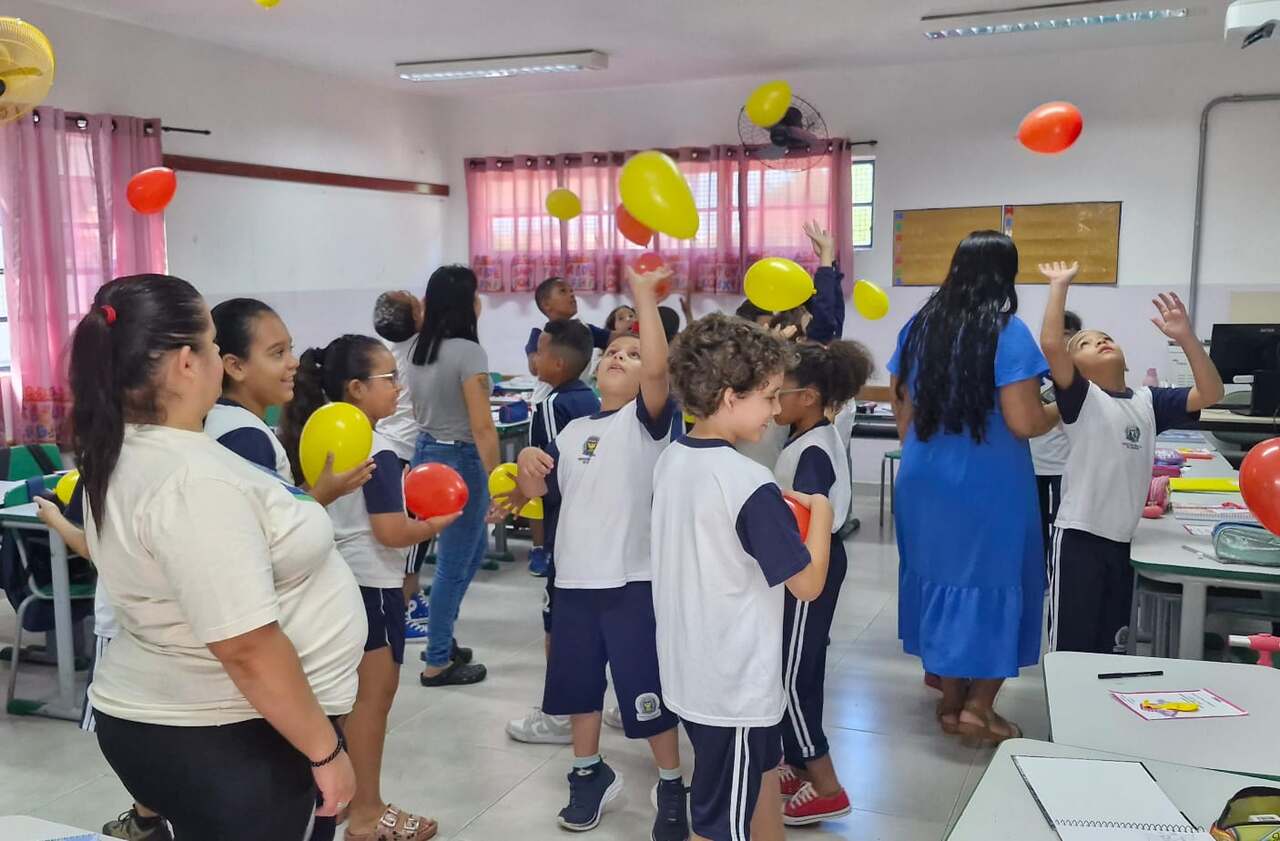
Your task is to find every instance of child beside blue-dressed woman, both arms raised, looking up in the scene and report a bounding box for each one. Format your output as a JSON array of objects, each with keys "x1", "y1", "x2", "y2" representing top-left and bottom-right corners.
[{"x1": 1041, "y1": 262, "x2": 1224, "y2": 653}]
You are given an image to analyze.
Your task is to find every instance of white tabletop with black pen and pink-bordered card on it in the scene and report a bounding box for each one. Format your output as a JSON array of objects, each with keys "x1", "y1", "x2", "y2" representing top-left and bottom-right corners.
[{"x1": 1043, "y1": 652, "x2": 1280, "y2": 777}]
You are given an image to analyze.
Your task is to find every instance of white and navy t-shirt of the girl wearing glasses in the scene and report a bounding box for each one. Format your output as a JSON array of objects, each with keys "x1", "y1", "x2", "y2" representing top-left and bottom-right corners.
[{"x1": 326, "y1": 430, "x2": 407, "y2": 589}]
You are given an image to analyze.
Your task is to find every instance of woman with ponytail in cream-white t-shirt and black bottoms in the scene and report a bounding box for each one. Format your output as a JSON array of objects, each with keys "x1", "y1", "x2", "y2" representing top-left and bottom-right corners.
[{"x1": 70, "y1": 274, "x2": 366, "y2": 841}]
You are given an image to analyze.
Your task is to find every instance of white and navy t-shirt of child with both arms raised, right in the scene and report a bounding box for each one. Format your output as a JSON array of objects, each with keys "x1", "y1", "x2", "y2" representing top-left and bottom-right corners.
[{"x1": 1055, "y1": 371, "x2": 1199, "y2": 543}]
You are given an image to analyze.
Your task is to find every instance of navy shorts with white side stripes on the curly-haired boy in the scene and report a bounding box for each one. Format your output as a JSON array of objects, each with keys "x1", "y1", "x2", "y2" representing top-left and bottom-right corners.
[{"x1": 681, "y1": 719, "x2": 782, "y2": 841}]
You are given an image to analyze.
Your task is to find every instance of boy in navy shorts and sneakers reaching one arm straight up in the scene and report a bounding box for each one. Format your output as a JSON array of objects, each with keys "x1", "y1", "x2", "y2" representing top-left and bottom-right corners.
[{"x1": 517, "y1": 269, "x2": 689, "y2": 841}]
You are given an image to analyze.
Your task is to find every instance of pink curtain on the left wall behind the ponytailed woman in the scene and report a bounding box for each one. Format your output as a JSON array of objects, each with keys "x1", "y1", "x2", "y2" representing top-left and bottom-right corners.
[{"x1": 0, "y1": 108, "x2": 166, "y2": 442}]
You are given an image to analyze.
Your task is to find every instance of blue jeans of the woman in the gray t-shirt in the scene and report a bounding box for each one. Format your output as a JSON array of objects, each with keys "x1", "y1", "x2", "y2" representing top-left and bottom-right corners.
[{"x1": 413, "y1": 433, "x2": 489, "y2": 668}]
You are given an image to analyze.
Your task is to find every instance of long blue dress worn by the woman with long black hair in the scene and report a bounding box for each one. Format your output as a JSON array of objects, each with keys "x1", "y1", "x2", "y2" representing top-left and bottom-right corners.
[{"x1": 888, "y1": 316, "x2": 1048, "y2": 678}]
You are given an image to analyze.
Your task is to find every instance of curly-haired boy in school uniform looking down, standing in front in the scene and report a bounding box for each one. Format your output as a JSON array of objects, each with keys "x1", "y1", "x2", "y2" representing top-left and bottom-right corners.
[{"x1": 652, "y1": 314, "x2": 832, "y2": 841}]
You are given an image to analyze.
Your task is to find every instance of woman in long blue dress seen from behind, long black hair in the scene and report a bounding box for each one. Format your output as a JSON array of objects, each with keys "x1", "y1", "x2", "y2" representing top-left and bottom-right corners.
[{"x1": 888, "y1": 230, "x2": 1056, "y2": 742}]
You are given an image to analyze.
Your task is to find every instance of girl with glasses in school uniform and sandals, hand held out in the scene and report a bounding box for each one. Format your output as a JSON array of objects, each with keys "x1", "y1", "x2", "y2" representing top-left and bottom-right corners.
[{"x1": 284, "y1": 335, "x2": 462, "y2": 841}]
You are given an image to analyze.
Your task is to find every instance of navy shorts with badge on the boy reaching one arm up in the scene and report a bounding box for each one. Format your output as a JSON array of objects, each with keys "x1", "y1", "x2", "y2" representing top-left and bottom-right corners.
[{"x1": 543, "y1": 581, "x2": 680, "y2": 739}]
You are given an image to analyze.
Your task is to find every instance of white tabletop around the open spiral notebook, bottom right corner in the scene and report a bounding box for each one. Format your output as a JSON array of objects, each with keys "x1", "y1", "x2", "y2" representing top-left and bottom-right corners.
[{"x1": 947, "y1": 737, "x2": 1260, "y2": 841}]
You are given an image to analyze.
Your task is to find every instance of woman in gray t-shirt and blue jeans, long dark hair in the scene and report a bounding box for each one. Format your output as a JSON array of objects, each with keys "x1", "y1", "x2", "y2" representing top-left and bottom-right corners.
[{"x1": 408, "y1": 266, "x2": 498, "y2": 686}]
